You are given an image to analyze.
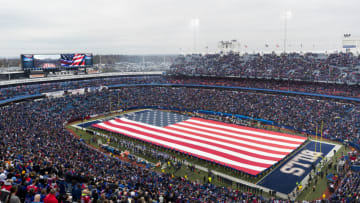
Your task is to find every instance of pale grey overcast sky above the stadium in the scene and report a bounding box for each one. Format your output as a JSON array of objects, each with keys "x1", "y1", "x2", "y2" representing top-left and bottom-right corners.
[{"x1": 0, "y1": 0, "x2": 360, "y2": 56}]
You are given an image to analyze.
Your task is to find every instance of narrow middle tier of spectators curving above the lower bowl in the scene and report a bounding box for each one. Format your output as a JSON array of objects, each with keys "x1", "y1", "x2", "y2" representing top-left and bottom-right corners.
[{"x1": 0, "y1": 76, "x2": 360, "y2": 100}]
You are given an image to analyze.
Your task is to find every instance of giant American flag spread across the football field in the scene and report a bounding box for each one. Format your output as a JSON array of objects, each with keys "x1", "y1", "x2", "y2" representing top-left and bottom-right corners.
[{"x1": 92, "y1": 110, "x2": 306, "y2": 175}]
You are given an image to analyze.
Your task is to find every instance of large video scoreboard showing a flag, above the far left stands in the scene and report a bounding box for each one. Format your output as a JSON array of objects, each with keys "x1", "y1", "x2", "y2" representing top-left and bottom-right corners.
[{"x1": 21, "y1": 53, "x2": 93, "y2": 70}]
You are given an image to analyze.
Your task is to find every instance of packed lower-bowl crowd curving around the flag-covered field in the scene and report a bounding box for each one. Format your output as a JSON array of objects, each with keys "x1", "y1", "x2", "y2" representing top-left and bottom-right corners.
[{"x1": 0, "y1": 79, "x2": 360, "y2": 202}]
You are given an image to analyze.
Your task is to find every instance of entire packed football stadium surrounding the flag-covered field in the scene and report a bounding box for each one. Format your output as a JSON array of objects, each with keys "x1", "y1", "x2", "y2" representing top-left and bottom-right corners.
[{"x1": 0, "y1": 0, "x2": 360, "y2": 203}]
